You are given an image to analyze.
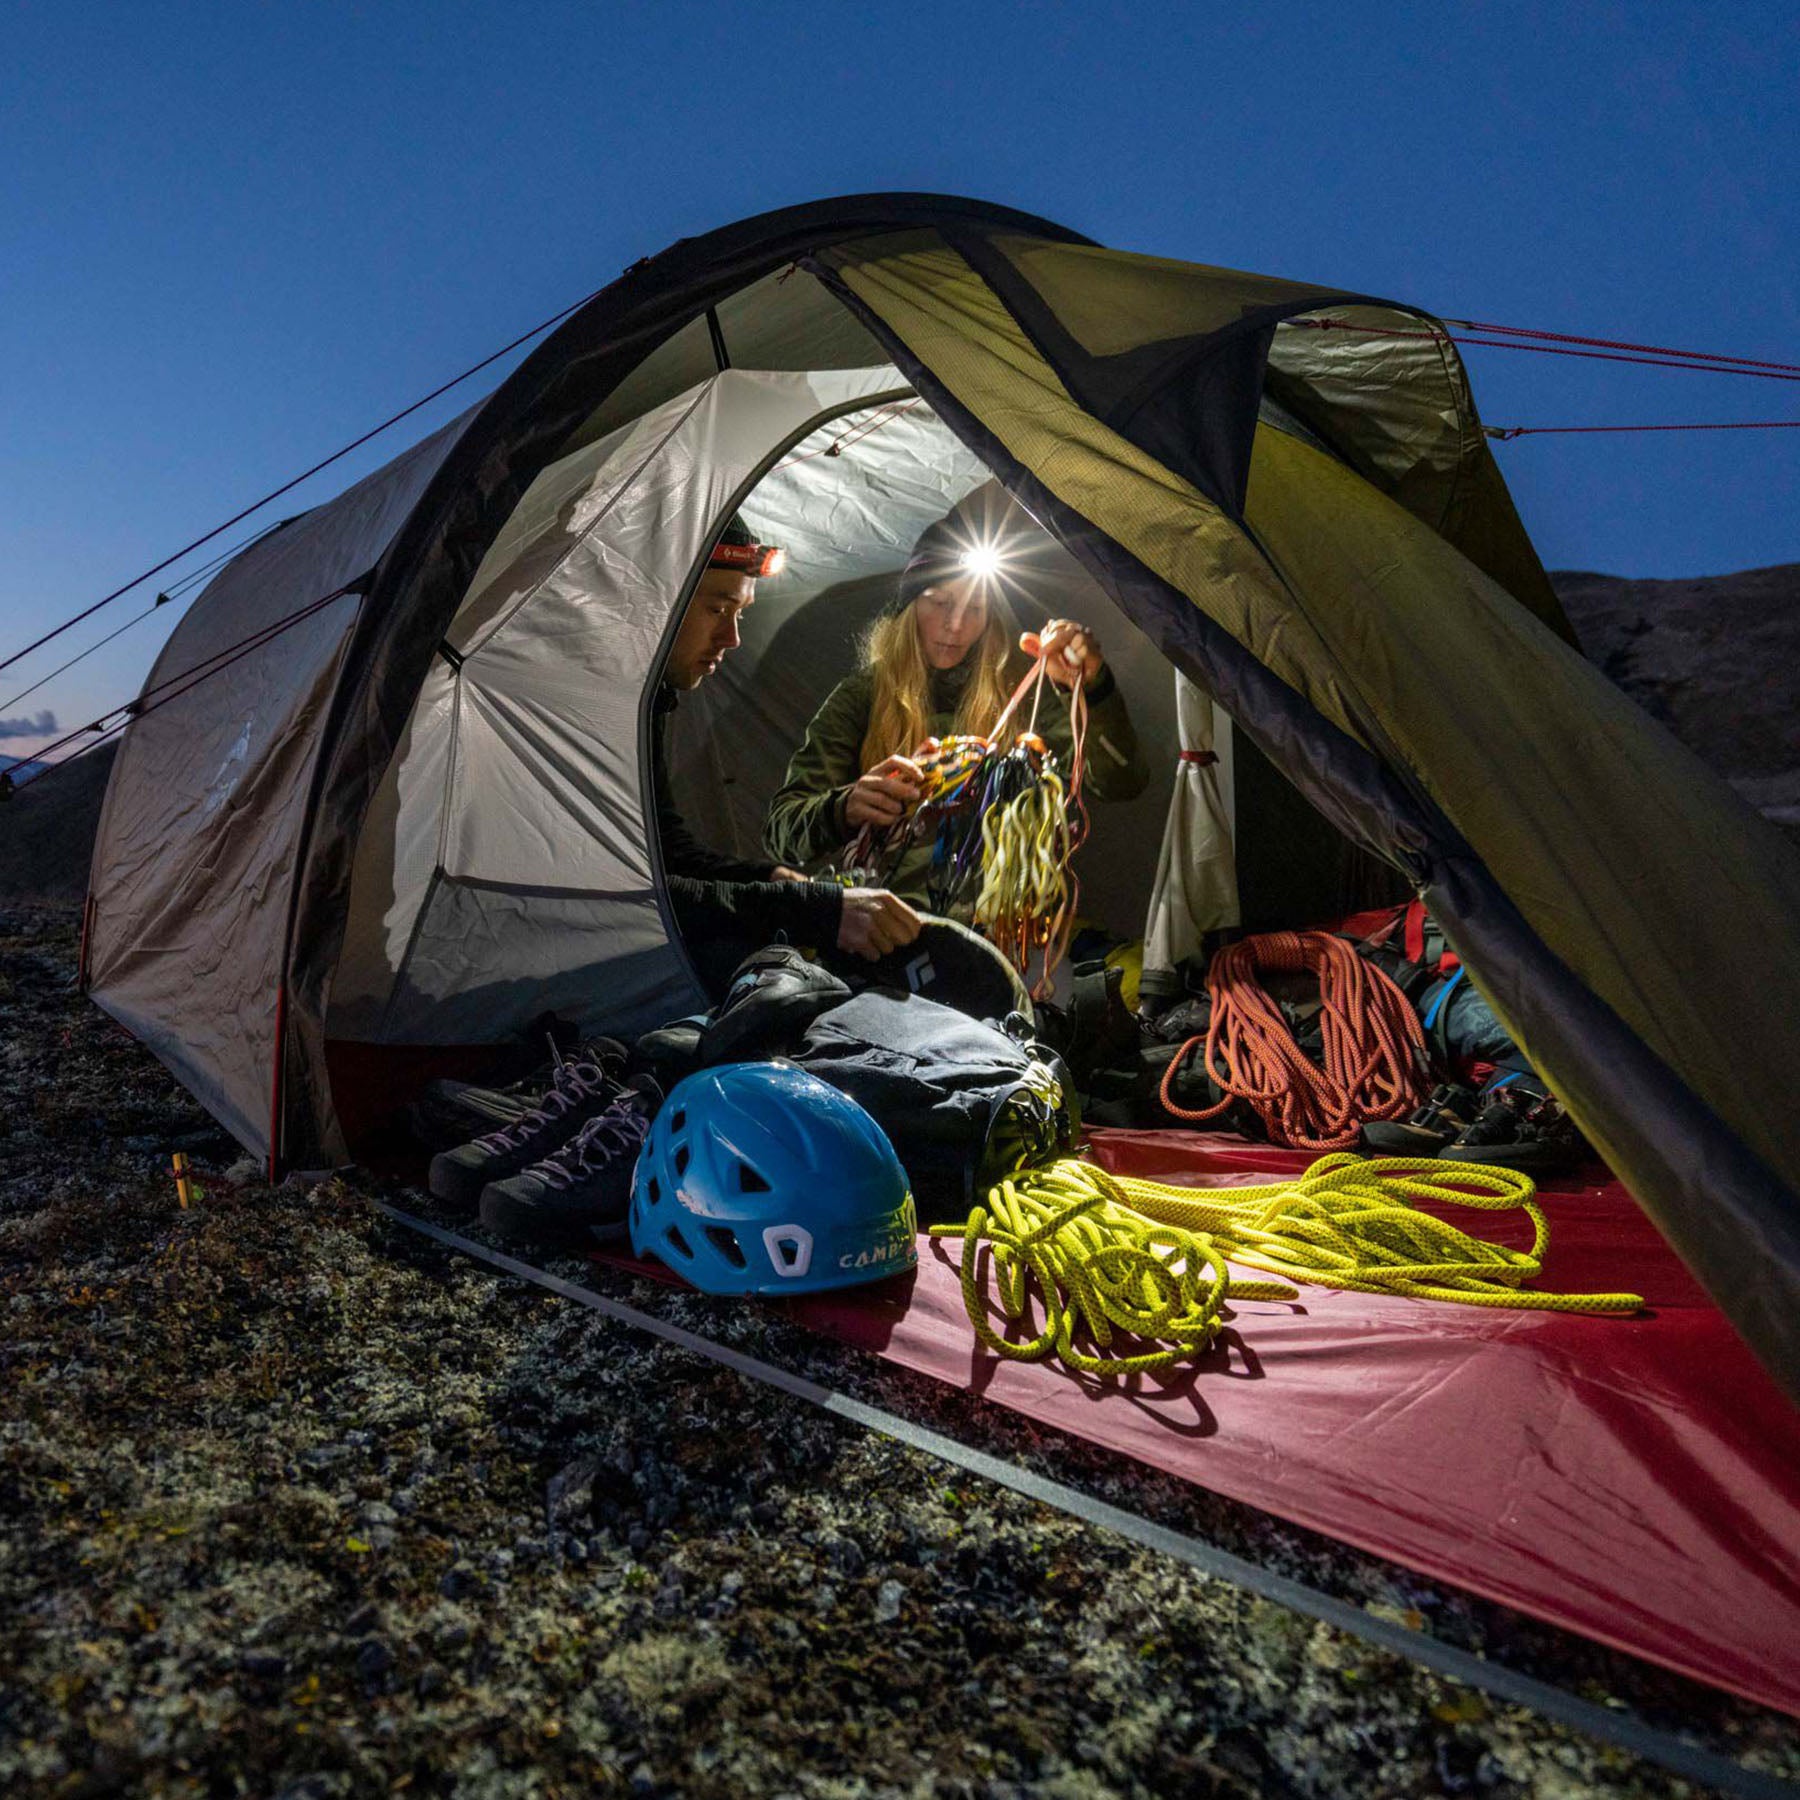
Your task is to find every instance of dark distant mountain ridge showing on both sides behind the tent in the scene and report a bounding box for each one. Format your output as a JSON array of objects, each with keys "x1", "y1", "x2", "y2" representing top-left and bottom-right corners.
[{"x1": 0, "y1": 563, "x2": 1800, "y2": 898}]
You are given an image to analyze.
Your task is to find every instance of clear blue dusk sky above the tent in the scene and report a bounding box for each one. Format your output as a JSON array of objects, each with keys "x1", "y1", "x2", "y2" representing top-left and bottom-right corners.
[{"x1": 0, "y1": 0, "x2": 1800, "y2": 756}]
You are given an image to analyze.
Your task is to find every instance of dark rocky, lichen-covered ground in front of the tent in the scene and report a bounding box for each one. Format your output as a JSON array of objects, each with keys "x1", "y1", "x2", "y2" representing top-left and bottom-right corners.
[{"x1": 0, "y1": 904, "x2": 1800, "y2": 1800}]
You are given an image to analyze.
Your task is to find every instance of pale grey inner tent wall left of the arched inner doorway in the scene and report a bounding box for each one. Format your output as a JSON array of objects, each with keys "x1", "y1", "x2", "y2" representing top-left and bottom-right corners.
[{"x1": 329, "y1": 367, "x2": 898, "y2": 1044}]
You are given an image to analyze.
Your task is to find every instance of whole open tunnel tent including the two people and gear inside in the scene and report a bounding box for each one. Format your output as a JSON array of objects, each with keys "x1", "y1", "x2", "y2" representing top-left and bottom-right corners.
[{"x1": 56, "y1": 196, "x2": 1800, "y2": 1708}]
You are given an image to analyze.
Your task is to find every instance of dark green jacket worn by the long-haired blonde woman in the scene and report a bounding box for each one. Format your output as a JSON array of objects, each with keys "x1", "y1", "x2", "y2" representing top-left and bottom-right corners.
[{"x1": 763, "y1": 664, "x2": 1150, "y2": 905}]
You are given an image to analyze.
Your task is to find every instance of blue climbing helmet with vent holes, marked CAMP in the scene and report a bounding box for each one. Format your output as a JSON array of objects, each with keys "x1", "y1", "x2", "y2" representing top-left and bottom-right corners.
[{"x1": 632, "y1": 1062, "x2": 918, "y2": 1294}]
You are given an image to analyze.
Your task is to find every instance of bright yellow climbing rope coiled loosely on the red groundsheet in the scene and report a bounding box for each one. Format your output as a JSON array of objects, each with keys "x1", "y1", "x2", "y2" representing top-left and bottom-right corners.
[{"x1": 931, "y1": 1152, "x2": 1643, "y2": 1375}]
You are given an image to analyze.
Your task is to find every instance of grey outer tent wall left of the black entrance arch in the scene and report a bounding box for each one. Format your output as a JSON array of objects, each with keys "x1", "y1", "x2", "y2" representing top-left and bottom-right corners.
[{"x1": 86, "y1": 412, "x2": 472, "y2": 1154}]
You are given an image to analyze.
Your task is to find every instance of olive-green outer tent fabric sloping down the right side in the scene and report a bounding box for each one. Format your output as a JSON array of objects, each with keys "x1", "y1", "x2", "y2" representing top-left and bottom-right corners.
[{"x1": 813, "y1": 225, "x2": 1800, "y2": 1379}]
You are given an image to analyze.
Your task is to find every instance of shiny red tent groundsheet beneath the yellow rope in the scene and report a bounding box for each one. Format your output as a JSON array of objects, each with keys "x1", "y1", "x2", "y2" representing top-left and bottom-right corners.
[{"x1": 608, "y1": 1130, "x2": 1800, "y2": 1714}]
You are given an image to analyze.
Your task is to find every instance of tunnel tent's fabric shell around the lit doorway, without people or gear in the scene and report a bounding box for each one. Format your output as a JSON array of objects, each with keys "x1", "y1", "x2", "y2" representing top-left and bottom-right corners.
[{"x1": 85, "y1": 194, "x2": 1800, "y2": 1386}]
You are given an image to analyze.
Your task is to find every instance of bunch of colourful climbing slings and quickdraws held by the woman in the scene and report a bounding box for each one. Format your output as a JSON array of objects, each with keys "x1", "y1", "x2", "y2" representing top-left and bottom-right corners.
[{"x1": 841, "y1": 657, "x2": 1087, "y2": 999}]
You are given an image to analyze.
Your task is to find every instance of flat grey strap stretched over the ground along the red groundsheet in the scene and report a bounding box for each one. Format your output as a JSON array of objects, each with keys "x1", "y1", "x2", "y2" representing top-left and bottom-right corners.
[{"x1": 369, "y1": 1201, "x2": 1800, "y2": 1800}]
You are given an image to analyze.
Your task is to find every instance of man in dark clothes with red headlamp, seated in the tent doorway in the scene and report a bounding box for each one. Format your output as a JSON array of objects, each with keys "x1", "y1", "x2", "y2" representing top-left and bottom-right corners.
[{"x1": 650, "y1": 517, "x2": 920, "y2": 988}]
